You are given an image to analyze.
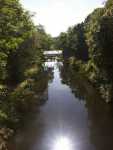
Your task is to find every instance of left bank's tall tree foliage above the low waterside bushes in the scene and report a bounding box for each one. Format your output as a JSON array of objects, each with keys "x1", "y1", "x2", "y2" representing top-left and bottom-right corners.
[{"x1": 0, "y1": 0, "x2": 52, "y2": 84}]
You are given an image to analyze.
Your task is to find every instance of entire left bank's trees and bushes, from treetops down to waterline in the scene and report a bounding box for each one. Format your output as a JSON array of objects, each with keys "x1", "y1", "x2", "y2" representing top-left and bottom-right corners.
[{"x1": 0, "y1": 0, "x2": 51, "y2": 150}]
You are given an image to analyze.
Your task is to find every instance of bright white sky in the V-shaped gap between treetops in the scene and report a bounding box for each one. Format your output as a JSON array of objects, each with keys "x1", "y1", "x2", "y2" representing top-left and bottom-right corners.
[{"x1": 20, "y1": 0, "x2": 104, "y2": 37}]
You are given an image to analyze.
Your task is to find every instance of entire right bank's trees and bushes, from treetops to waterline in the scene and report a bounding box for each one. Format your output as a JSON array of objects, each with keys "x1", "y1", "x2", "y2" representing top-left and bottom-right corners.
[{"x1": 57, "y1": 0, "x2": 113, "y2": 102}]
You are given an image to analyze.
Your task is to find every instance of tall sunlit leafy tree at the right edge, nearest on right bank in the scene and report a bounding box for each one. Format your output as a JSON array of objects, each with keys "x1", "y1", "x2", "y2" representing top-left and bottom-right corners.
[{"x1": 85, "y1": 0, "x2": 113, "y2": 101}]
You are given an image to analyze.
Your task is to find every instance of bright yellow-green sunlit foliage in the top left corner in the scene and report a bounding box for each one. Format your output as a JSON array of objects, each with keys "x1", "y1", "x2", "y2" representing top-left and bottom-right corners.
[{"x1": 0, "y1": 0, "x2": 33, "y2": 54}]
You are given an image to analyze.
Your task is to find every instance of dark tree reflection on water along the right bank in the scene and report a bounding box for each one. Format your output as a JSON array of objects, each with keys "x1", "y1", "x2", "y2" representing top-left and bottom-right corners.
[{"x1": 60, "y1": 62, "x2": 113, "y2": 150}]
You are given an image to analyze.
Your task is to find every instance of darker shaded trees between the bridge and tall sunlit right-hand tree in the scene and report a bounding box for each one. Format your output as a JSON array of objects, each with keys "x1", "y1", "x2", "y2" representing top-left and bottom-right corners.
[{"x1": 56, "y1": 23, "x2": 88, "y2": 61}]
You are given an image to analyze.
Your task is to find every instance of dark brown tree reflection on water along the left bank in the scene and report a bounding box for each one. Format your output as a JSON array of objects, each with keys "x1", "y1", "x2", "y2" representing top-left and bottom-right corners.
[{"x1": 8, "y1": 71, "x2": 49, "y2": 150}]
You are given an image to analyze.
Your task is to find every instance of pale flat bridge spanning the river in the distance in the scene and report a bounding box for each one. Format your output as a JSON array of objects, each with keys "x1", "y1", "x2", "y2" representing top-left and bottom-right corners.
[{"x1": 44, "y1": 50, "x2": 62, "y2": 59}]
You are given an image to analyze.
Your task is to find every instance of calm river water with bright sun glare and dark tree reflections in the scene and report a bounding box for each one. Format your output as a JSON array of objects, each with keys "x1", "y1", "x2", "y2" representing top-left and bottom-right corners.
[{"x1": 9, "y1": 62, "x2": 113, "y2": 150}]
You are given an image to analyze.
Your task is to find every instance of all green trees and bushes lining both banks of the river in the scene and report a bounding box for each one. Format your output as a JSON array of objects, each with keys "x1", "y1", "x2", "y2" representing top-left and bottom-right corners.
[{"x1": 0, "y1": 0, "x2": 113, "y2": 150}]
